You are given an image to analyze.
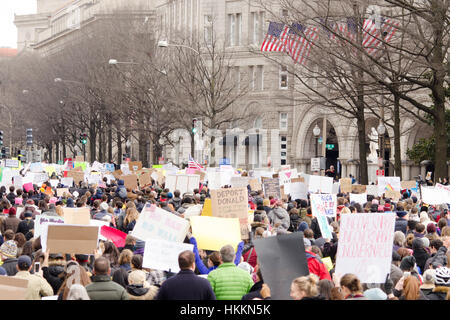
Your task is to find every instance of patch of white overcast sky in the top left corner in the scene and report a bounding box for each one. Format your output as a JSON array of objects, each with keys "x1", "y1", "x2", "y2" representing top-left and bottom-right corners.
[{"x1": 0, "y1": 0, "x2": 36, "y2": 48}]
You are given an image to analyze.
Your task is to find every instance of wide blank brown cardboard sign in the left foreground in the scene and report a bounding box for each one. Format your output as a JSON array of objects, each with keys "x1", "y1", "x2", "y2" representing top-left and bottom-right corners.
[{"x1": 42, "y1": 224, "x2": 99, "y2": 254}]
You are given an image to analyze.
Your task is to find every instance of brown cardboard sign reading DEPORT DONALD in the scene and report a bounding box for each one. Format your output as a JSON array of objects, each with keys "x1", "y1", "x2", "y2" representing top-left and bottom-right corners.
[{"x1": 210, "y1": 187, "x2": 248, "y2": 239}]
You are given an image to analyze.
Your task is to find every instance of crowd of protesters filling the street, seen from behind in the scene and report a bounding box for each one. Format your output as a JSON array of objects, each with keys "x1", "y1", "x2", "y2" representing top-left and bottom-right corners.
[{"x1": 0, "y1": 168, "x2": 450, "y2": 300}]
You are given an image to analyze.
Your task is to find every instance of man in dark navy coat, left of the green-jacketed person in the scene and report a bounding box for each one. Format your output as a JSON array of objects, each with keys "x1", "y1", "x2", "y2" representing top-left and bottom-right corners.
[{"x1": 156, "y1": 250, "x2": 216, "y2": 300}]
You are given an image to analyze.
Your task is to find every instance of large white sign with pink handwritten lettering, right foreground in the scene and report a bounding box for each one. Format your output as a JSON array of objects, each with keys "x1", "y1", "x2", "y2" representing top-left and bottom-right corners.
[{"x1": 336, "y1": 212, "x2": 395, "y2": 283}]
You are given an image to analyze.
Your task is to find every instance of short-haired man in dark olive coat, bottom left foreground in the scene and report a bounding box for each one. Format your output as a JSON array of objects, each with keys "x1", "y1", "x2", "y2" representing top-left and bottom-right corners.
[{"x1": 86, "y1": 257, "x2": 129, "y2": 300}]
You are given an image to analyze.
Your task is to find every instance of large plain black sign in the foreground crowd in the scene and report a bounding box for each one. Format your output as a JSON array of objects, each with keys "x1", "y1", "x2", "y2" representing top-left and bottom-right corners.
[{"x1": 253, "y1": 232, "x2": 309, "y2": 300}]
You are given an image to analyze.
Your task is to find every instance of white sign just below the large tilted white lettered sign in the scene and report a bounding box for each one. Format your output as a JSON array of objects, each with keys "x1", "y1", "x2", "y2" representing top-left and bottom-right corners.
[{"x1": 142, "y1": 239, "x2": 194, "y2": 273}]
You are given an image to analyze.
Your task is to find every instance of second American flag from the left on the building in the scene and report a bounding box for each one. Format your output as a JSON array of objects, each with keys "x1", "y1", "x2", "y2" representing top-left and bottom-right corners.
[{"x1": 288, "y1": 23, "x2": 319, "y2": 65}]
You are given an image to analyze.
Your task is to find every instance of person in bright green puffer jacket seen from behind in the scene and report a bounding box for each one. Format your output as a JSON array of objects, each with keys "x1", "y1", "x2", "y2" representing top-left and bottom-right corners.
[{"x1": 208, "y1": 245, "x2": 254, "y2": 300}]
